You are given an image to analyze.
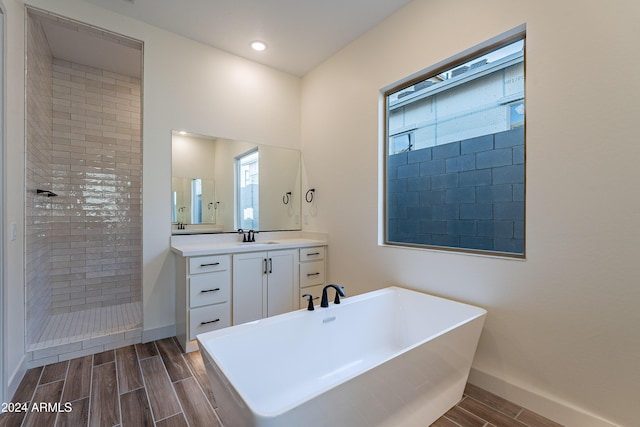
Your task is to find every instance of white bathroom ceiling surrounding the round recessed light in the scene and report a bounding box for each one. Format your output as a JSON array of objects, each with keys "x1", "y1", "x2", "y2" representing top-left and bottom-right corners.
[{"x1": 79, "y1": 0, "x2": 411, "y2": 76}]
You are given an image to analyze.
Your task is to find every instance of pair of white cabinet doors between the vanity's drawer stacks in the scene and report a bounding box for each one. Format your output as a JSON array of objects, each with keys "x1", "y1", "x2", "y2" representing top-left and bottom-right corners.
[{"x1": 233, "y1": 249, "x2": 299, "y2": 325}]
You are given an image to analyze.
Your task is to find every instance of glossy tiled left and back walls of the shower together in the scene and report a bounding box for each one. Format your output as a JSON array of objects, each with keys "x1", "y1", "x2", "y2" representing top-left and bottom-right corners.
[{"x1": 26, "y1": 15, "x2": 142, "y2": 345}]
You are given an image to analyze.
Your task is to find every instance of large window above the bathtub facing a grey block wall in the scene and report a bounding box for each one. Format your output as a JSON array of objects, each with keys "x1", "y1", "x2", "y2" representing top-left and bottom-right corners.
[{"x1": 384, "y1": 31, "x2": 525, "y2": 257}]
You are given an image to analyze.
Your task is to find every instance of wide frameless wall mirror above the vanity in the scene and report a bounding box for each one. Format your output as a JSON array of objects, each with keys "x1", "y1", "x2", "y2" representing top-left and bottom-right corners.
[{"x1": 171, "y1": 131, "x2": 301, "y2": 234}]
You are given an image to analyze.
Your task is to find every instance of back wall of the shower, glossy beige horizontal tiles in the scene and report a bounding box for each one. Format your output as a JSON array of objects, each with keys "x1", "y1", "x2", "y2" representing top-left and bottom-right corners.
[{"x1": 51, "y1": 59, "x2": 142, "y2": 314}]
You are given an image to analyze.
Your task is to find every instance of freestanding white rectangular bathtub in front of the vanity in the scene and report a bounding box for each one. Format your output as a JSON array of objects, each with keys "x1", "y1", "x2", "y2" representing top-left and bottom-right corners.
[{"x1": 198, "y1": 287, "x2": 486, "y2": 427}]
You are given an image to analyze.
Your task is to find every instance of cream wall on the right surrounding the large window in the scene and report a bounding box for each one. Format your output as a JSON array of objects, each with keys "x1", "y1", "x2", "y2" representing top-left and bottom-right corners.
[{"x1": 302, "y1": 0, "x2": 640, "y2": 426}]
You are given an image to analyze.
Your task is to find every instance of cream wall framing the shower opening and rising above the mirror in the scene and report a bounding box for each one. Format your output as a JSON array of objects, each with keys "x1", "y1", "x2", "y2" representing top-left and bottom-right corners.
[{"x1": 2, "y1": 0, "x2": 300, "y2": 394}]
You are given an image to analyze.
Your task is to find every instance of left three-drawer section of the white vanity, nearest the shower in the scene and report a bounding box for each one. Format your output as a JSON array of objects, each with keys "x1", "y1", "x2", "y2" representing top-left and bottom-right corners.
[{"x1": 176, "y1": 255, "x2": 231, "y2": 352}]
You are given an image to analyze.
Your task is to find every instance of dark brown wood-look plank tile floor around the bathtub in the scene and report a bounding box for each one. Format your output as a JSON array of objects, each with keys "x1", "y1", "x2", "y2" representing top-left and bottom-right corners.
[{"x1": 0, "y1": 338, "x2": 560, "y2": 427}]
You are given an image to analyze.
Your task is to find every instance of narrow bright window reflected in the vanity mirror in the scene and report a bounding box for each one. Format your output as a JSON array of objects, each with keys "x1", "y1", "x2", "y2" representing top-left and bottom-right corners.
[{"x1": 236, "y1": 150, "x2": 259, "y2": 230}]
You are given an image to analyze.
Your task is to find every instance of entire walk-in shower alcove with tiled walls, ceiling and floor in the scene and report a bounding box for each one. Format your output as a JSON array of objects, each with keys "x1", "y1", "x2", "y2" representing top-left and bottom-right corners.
[{"x1": 25, "y1": 8, "x2": 143, "y2": 366}]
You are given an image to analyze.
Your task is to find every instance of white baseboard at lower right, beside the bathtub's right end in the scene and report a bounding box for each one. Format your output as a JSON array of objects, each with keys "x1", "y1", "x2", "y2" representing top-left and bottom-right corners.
[{"x1": 469, "y1": 368, "x2": 619, "y2": 427}]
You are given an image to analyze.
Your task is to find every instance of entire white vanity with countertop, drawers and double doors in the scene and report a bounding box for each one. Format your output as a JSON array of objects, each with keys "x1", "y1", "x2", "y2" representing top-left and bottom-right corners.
[{"x1": 171, "y1": 234, "x2": 326, "y2": 352}]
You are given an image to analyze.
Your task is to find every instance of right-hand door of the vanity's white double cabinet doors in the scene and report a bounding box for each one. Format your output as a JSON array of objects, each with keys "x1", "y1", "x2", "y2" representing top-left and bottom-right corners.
[{"x1": 267, "y1": 250, "x2": 299, "y2": 316}]
